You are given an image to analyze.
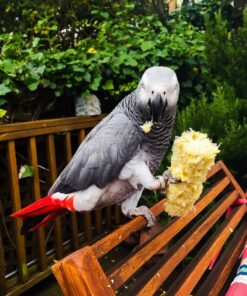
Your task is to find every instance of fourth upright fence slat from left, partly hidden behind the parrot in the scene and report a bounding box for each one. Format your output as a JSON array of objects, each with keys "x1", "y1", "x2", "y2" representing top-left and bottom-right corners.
[{"x1": 65, "y1": 132, "x2": 79, "y2": 250}]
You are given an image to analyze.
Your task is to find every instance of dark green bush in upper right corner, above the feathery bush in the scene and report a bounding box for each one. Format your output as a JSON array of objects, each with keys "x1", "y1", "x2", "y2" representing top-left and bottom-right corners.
[{"x1": 205, "y1": 9, "x2": 247, "y2": 99}]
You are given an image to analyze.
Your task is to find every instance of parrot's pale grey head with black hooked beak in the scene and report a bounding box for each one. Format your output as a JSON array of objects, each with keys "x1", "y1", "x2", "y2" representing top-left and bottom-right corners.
[{"x1": 137, "y1": 66, "x2": 179, "y2": 122}]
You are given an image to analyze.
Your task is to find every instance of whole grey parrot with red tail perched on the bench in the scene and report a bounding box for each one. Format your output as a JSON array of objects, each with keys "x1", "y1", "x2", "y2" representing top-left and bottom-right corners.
[{"x1": 12, "y1": 67, "x2": 179, "y2": 232}]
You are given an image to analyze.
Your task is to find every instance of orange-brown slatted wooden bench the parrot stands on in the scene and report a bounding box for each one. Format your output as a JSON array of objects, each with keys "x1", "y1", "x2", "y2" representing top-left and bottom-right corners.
[{"x1": 52, "y1": 161, "x2": 247, "y2": 296}]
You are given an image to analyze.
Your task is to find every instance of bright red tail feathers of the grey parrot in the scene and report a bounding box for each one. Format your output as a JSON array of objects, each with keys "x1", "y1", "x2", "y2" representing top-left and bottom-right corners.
[{"x1": 11, "y1": 195, "x2": 74, "y2": 233}]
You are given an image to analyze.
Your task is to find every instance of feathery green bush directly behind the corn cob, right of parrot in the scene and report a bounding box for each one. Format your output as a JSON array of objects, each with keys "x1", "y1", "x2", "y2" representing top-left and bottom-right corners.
[{"x1": 174, "y1": 86, "x2": 247, "y2": 178}]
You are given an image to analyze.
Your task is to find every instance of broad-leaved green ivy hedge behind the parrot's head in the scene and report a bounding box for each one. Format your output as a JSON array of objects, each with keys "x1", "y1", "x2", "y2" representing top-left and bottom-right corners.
[{"x1": 0, "y1": 4, "x2": 206, "y2": 118}]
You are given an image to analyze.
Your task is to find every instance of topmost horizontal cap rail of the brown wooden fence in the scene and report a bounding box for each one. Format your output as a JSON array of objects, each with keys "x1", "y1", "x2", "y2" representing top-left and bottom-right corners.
[{"x1": 0, "y1": 114, "x2": 105, "y2": 134}]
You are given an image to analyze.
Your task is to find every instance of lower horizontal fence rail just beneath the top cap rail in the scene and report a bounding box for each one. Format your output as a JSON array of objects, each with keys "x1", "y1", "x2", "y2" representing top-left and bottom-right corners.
[{"x1": 0, "y1": 120, "x2": 103, "y2": 142}]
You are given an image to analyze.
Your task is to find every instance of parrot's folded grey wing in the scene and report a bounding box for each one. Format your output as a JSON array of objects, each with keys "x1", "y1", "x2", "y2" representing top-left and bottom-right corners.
[{"x1": 49, "y1": 113, "x2": 142, "y2": 193}]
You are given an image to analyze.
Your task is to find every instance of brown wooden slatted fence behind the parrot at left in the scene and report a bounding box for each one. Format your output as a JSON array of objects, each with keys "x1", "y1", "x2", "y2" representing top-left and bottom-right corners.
[{"x1": 0, "y1": 116, "x2": 121, "y2": 295}]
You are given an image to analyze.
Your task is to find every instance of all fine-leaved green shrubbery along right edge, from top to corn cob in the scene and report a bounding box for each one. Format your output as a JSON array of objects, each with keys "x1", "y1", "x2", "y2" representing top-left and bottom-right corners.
[{"x1": 175, "y1": 6, "x2": 247, "y2": 175}]
